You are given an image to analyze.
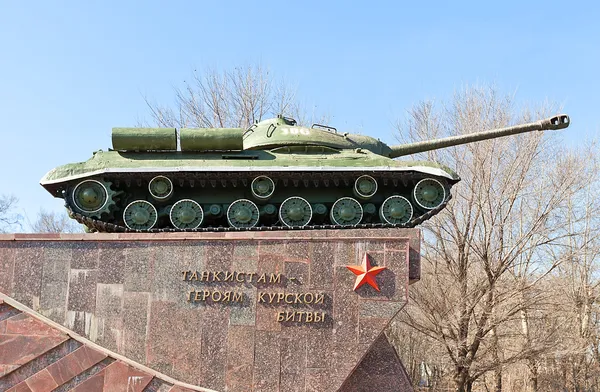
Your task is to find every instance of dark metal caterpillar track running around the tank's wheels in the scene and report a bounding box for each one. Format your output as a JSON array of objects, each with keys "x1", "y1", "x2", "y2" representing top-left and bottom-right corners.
[{"x1": 65, "y1": 171, "x2": 452, "y2": 233}]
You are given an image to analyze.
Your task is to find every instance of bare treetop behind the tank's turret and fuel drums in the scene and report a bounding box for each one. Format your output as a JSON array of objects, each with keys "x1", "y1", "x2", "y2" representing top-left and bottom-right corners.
[{"x1": 146, "y1": 65, "x2": 325, "y2": 128}]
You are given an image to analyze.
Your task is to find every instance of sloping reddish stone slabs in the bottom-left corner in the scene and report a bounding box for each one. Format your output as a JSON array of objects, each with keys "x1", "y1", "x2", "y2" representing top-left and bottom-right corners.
[{"x1": 0, "y1": 299, "x2": 207, "y2": 392}]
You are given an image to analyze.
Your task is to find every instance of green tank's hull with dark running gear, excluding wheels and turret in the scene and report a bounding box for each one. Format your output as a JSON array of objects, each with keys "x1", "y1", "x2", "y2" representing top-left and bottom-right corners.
[{"x1": 40, "y1": 150, "x2": 459, "y2": 232}]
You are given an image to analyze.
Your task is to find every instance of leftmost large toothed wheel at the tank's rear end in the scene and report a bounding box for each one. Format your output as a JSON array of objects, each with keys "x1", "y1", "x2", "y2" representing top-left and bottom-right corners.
[{"x1": 71, "y1": 180, "x2": 115, "y2": 218}]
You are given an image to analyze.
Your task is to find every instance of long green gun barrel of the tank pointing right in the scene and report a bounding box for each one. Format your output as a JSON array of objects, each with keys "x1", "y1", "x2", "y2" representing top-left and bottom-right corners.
[{"x1": 389, "y1": 114, "x2": 570, "y2": 158}]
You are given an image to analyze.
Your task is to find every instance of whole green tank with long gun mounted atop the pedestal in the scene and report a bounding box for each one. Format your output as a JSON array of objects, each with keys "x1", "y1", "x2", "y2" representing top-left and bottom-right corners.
[{"x1": 41, "y1": 114, "x2": 569, "y2": 232}]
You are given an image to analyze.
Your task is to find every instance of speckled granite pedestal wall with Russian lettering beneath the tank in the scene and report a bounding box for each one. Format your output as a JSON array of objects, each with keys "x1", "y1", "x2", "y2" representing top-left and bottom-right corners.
[{"x1": 0, "y1": 229, "x2": 420, "y2": 392}]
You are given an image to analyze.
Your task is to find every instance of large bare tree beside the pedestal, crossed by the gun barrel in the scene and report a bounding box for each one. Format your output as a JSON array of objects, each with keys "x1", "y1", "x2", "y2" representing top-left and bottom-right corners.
[{"x1": 390, "y1": 88, "x2": 589, "y2": 392}]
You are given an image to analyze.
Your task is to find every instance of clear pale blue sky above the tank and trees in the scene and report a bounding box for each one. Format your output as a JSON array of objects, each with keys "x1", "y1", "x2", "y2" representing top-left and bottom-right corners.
[{"x1": 0, "y1": 0, "x2": 600, "y2": 228}]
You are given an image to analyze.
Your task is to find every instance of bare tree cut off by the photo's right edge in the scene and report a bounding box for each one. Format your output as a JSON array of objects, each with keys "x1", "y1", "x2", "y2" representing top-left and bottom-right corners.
[{"x1": 544, "y1": 154, "x2": 600, "y2": 391}]
